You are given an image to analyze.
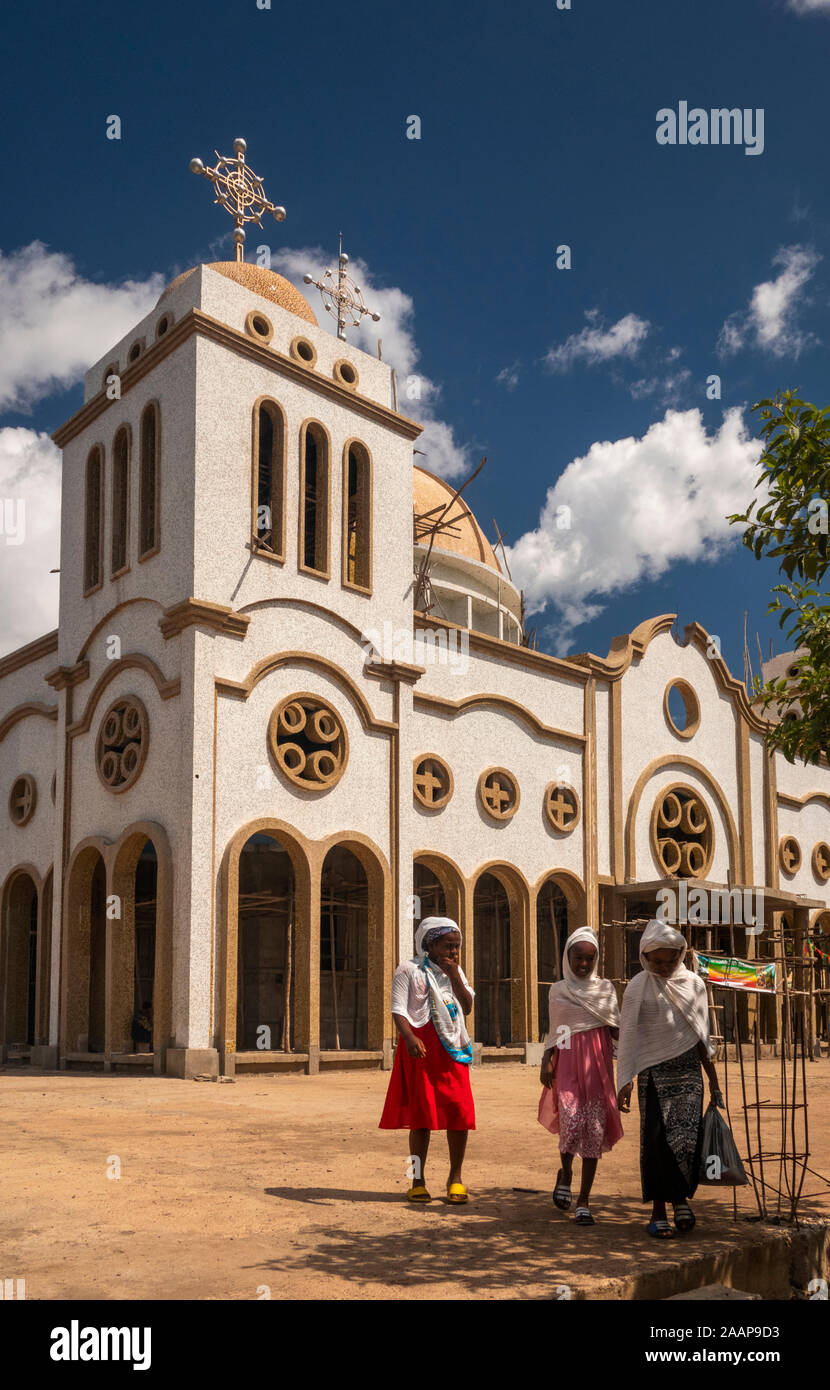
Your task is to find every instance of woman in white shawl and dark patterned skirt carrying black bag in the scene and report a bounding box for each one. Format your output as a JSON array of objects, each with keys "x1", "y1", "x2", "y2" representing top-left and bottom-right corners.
[{"x1": 617, "y1": 920, "x2": 723, "y2": 1240}]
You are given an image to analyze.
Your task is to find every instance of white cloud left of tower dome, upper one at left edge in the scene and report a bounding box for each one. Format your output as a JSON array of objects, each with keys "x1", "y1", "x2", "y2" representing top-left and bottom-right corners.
[{"x1": 0, "y1": 242, "x2": 164, "y2": 410}]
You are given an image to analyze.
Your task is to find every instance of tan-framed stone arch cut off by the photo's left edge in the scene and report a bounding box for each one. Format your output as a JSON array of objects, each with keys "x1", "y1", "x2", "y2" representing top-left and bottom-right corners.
[{"x1": 0, "y1": 862, "x2": 43, "y2": 1061}]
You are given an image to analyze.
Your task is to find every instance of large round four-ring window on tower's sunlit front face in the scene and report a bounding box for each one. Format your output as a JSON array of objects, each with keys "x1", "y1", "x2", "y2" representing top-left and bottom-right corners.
[{"x1": 268, "y1": 694, "x2": 349, "y2": 791}]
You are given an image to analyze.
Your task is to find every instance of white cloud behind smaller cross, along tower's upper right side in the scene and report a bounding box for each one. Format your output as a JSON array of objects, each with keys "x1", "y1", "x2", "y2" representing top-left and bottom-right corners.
[{"x1": 271, "y1": 246, "x2": 470, "y2": 478}]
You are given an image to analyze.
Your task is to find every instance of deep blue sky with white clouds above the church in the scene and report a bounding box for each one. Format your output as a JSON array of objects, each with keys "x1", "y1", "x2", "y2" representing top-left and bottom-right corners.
[{"x1": 0, "y1": 0, "x2": 830, "y2": 674}]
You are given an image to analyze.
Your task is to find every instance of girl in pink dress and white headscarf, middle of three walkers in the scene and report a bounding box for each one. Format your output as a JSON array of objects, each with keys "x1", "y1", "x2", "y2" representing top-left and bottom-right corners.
[{"x1": 539, "y1": 927, "x2": 623, "y2": 1226}]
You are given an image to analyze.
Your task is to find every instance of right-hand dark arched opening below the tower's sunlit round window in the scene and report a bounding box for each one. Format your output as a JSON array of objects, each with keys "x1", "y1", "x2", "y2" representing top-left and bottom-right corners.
[{"x1": 320, "y1": 845, "x2": 368, "y2": 1052}]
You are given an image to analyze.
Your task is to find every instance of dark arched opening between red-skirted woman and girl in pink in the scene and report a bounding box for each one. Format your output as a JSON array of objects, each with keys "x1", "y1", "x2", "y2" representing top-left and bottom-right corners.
[{"x1": 473, "y1": 873, "x2": 513, "y2": 1047}]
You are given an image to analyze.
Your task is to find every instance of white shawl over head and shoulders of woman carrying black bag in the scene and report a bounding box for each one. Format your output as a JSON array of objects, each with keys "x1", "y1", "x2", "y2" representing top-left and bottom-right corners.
[{"x1": 617, "y1": 919, "x2": 715, "y2": 1090}]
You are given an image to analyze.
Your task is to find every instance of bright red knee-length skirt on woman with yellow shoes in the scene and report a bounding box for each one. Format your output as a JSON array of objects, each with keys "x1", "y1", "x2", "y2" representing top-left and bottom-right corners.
[{"x1": 378, "y1": 1023, "x2": 475, "y2": 1129}]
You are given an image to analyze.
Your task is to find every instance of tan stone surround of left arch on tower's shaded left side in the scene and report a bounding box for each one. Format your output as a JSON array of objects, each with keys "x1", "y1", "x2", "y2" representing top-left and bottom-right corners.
[{"x1": 58, "y1": 835, "x2": 111, "y2": 1062}]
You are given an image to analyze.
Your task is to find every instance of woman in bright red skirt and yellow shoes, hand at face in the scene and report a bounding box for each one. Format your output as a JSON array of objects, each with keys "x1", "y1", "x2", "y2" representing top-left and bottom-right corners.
[{"x1": 378, "y1": 917, "x2": 475, "y2": 1204}]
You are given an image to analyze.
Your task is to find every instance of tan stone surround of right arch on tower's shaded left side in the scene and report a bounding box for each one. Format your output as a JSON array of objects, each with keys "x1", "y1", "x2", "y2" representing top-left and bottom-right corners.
[{"x1": 104, "y1": 820, "x2": 172, "y2": 1072}]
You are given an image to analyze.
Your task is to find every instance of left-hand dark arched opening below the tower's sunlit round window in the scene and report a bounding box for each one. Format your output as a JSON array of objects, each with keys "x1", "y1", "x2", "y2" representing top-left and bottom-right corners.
[{"x1": 236, "y1": 831, "x2": 296, "y2": 1052}]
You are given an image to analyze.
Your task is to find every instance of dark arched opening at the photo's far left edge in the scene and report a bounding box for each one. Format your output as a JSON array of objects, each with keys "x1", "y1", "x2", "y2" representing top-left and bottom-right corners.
[{"x1": 0, "y1": 872, "x2": 38, "y2": 1049}]
